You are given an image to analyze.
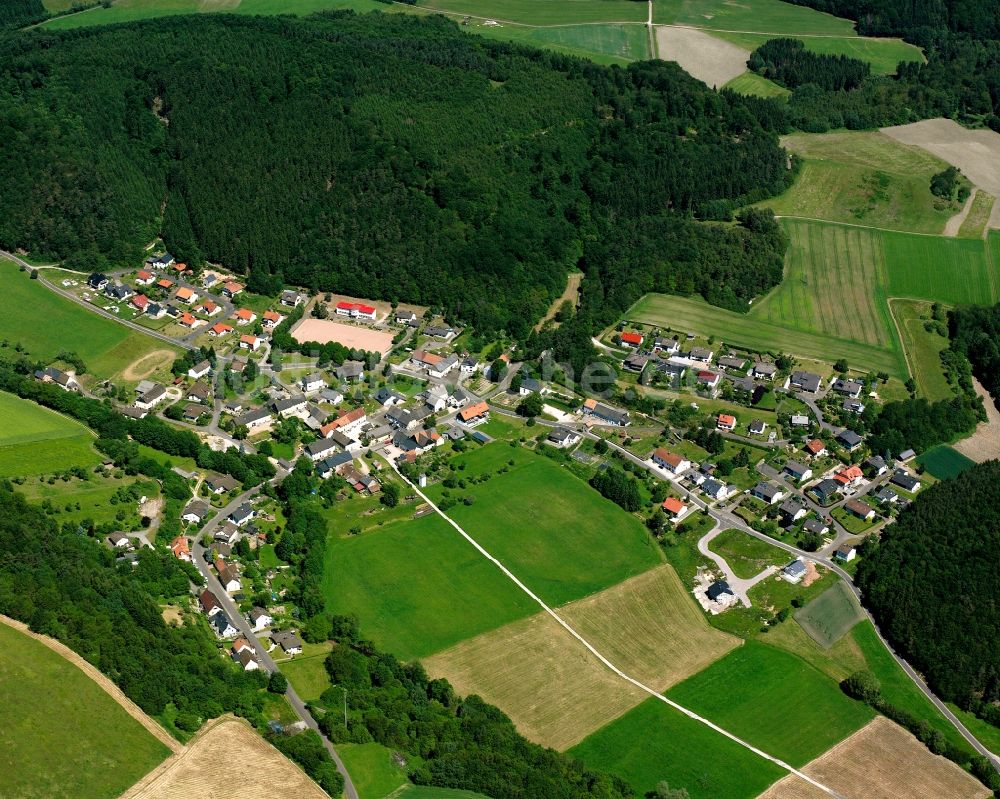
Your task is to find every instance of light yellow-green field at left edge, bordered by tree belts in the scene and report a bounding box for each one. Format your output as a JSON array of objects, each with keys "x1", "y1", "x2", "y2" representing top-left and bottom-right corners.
[{"x1": 0, "y1": 392, "x2": 101, "y2": 477}]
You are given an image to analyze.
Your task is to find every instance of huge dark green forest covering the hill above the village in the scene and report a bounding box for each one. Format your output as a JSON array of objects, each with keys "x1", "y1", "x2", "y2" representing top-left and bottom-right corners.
[{"x1": 0, "y1": 12, "x2": 792, "y2": 338}]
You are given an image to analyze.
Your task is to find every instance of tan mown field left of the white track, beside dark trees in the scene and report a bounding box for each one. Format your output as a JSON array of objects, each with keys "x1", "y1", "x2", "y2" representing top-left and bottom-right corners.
[{"x1": 423, "y1": 613, "x2": 646, "y2": 750}]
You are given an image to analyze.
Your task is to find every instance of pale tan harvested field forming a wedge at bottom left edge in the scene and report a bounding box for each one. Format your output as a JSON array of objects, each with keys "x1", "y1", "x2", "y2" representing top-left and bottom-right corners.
[{"x1": 120, "y1": 716, "x2": 328, "y2": 799}]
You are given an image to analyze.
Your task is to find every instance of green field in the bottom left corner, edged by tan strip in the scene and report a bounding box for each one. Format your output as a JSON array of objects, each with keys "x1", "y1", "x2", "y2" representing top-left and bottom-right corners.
[{"x1": 0, "y1": 624, "x2": 169, "y2": 799}]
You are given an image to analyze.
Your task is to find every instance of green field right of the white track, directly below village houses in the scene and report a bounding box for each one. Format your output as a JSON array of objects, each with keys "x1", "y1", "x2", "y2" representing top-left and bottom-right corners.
[{"x1": 427, "y1": 442, "x2": 662, "y2": 605}]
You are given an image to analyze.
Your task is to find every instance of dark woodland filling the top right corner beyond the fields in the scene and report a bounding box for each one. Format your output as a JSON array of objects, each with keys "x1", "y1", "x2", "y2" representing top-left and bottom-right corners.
[{"x1": 751, "y1": 0, "x2": 1000, "y2": 131}]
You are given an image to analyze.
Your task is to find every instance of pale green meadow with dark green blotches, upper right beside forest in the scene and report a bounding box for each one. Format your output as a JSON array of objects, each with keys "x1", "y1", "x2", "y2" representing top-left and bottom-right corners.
[{"x1": 760, "y1": 131, "x2": 960, "y2": 233}]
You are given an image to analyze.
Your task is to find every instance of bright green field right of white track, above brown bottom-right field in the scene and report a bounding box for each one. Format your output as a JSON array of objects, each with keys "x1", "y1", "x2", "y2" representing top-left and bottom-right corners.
[{"x1": 667, "y1": 641, "x2": 874, "y2": 766}]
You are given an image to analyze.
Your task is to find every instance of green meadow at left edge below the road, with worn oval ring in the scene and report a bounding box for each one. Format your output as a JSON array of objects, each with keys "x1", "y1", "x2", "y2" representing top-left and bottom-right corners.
[{"x1": 0, "y1": 258, "x2": 178, "y2": 379}]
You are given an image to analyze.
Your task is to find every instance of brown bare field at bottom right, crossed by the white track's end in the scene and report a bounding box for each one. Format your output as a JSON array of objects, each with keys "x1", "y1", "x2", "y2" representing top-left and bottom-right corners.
[{"x1": 759, "y1": 716, "x2": 991, "y2": 799}]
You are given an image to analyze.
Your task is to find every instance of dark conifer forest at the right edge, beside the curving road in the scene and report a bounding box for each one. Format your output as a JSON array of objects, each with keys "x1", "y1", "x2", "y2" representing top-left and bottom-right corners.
[{"x1": 856, "y1": 461, "x2": 1000, "y2": 723}]
